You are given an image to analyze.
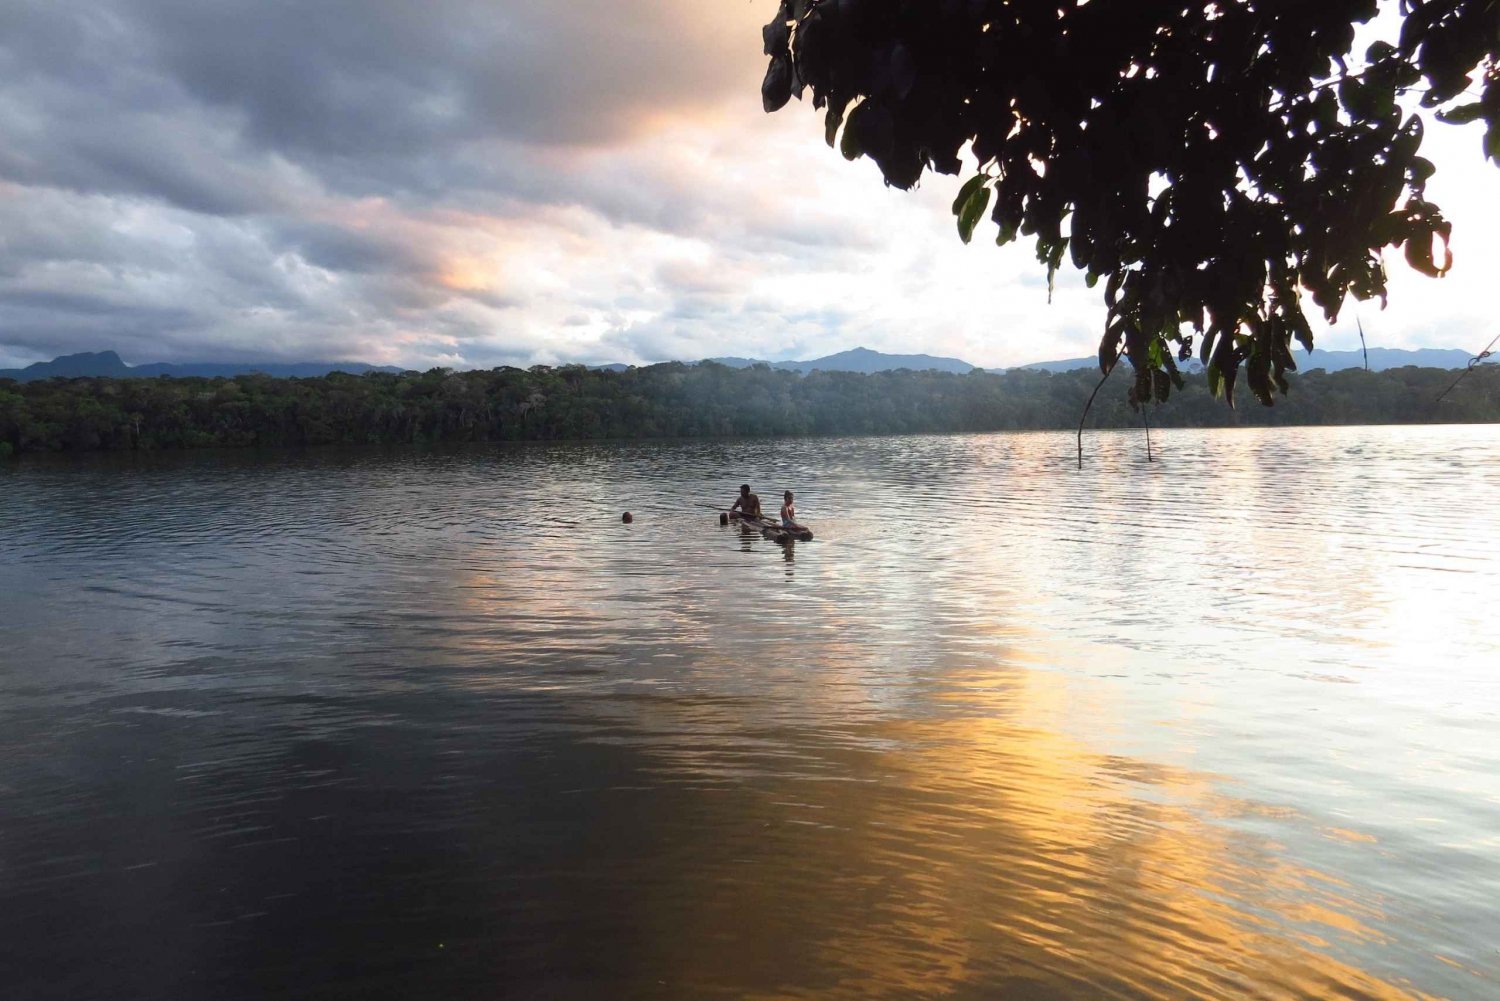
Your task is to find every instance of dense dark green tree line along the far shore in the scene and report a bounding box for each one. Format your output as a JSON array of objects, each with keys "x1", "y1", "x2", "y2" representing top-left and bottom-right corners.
[{"x1": 0, "y1": 362, "x2": 1500, "y2": 456}]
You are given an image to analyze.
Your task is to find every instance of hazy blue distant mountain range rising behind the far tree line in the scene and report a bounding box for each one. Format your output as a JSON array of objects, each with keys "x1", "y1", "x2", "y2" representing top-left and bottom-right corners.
[{"x1": 0, "y1": 340, "x2": 1472, "y2": 383}]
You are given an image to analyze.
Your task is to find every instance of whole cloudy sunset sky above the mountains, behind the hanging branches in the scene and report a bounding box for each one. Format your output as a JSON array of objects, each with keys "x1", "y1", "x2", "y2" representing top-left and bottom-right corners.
[{"x1": 0, "y1": 0, "x2": 1500, "y2": 368}]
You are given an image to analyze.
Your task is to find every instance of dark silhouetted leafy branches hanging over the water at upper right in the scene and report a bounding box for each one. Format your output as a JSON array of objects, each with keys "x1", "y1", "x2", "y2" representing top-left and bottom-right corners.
[{"x1": 762, "y1": 0, "x2": 1500, "y2": 405}]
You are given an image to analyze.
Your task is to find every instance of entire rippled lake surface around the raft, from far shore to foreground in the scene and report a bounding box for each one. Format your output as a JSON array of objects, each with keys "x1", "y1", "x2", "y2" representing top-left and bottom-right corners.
[{"x1": 0, "y1": 428, "x2": 1500, "y2": 1001}]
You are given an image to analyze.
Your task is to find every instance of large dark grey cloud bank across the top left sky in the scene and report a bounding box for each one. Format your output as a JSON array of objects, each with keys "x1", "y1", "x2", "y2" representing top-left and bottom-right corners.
[{"x1": 0, "y1": 0, "x2": 755, "y2": 213}]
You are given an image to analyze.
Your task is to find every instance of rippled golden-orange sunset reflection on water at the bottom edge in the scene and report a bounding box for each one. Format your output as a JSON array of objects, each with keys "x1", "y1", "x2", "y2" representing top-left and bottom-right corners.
[{"x1": 714, "y1": 660, "x2": 1413, "y2": 998}]
